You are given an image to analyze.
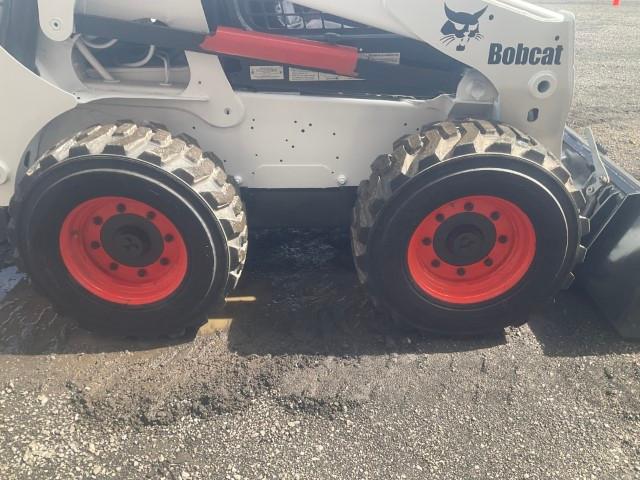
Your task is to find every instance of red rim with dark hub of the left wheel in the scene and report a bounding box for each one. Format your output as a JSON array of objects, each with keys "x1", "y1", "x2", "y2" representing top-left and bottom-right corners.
[{"x1": 60, "y1": 197, "x2": 188, "y2": 305}]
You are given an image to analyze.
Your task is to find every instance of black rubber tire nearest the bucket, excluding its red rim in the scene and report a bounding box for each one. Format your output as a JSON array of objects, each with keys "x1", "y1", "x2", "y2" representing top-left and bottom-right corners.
[{"x1": 351, "y1": 120, "x2": 589, "y2": 335}]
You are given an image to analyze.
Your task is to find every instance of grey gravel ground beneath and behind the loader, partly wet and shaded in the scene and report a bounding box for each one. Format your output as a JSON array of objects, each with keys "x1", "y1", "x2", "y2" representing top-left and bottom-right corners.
[{"x1": 0, "y1": 0, "x2": 640, "y2": 480}]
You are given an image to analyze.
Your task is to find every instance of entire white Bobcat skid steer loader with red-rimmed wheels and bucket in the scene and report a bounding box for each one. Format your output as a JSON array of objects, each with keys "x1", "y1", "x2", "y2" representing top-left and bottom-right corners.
[{"x1": 0, "y1": 0, "x2": 640, "y2": 338}]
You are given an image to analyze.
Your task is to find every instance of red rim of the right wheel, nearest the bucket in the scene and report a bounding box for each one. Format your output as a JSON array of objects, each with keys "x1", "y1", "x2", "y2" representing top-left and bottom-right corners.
[{"x1": 408, "y1": 196, "x2": 536, "y2": 305}]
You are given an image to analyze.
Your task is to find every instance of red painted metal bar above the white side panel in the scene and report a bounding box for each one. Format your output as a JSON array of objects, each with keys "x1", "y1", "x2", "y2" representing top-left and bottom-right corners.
[{"x1": 200, "y1": 27, "x2": 358, "y2": 76}]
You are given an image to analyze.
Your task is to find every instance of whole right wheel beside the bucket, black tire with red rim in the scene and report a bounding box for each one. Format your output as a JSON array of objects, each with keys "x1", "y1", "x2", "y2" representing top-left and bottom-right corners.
[{"x1": 352, "y1": 120, "x2": 588, "y2": 335}]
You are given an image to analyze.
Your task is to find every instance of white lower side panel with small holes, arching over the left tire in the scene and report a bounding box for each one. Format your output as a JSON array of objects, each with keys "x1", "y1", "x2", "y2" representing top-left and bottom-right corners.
[{"x1": 41, "y1": 93, "x2": 462, "y2": 188}]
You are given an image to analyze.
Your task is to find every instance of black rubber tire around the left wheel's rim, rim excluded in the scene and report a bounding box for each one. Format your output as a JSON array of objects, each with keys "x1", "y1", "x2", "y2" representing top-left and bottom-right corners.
[{"x1": 8, "y1": 121, "x2": 248, "y2": 337}]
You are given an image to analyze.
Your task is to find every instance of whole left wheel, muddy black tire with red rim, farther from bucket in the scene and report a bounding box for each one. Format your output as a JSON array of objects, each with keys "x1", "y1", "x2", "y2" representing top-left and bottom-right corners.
[{"x1": 9, "y1": 122, "x2": 248, "y2": 337}]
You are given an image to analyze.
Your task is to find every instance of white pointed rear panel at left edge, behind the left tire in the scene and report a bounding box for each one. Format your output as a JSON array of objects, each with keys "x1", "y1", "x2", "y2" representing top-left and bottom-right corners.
[{"x1": 0, "y1": 47, "x2": 76, "y2": 206}]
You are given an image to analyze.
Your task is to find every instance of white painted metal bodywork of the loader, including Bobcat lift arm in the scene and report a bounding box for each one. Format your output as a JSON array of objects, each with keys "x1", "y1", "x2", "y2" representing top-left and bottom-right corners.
[{"x1": 0, "y1": 0, "x2": 574, "y2": 206}]
